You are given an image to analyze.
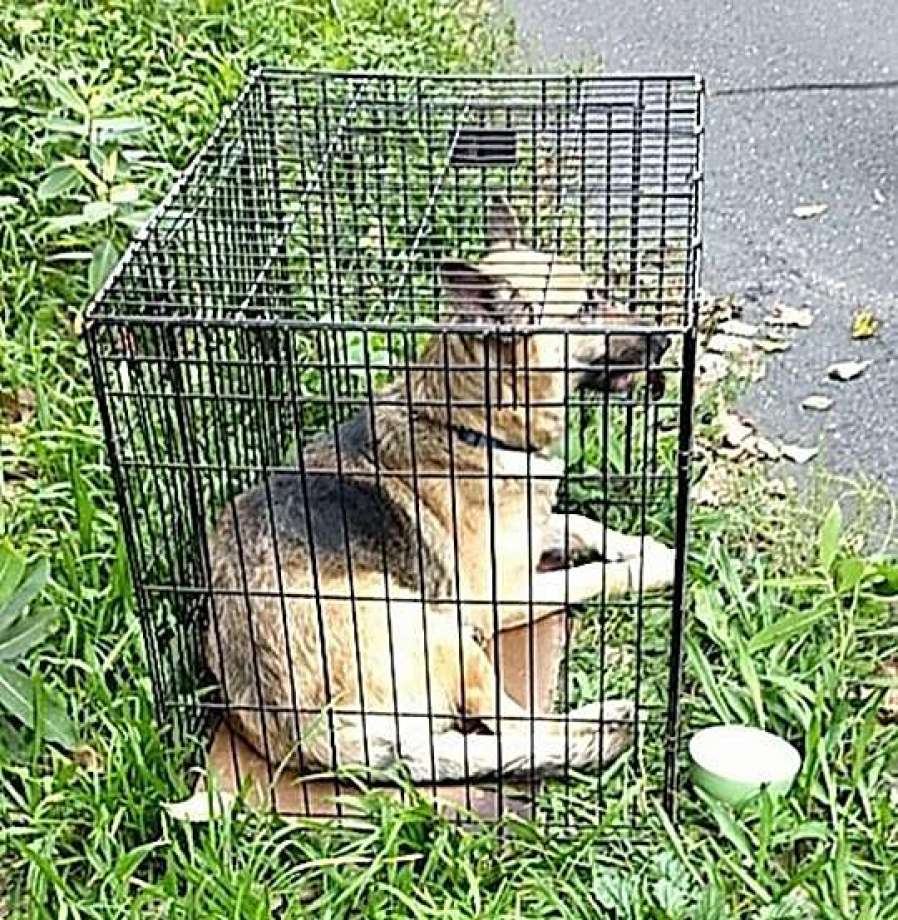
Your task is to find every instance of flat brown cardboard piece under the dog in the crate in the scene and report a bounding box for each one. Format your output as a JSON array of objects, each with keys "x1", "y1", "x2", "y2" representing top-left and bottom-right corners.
[{"x1": 194, "y1": 613, "x2": 574, "y2": 822}]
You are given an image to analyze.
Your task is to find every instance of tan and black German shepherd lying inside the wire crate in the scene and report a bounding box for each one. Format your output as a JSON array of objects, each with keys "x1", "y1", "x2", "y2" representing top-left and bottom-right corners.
[{"x1": 206, "y1": 198, "x2": 674, "y2": 782}]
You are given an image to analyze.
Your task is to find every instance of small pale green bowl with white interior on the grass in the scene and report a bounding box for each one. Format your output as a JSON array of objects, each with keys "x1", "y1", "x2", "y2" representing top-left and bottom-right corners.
[{"x1": 689, "y1": 725, "x2": 801, "y2": 805}]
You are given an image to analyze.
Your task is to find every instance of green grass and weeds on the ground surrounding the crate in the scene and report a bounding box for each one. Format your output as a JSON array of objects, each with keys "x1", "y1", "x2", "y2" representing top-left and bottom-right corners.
[{"x1": 0, "y1": 0, "x2": 898, "y2": 920}]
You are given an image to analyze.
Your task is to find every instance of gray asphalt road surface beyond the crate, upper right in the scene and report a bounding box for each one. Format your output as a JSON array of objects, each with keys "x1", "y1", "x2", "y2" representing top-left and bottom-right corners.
[{"x1": 510, "y1": 0, "x2": 898, "y2": 492}]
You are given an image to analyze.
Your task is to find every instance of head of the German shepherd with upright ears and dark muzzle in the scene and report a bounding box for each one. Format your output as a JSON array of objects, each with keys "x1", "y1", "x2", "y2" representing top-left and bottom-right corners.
[{"x1": 441, "y1": 198, "x2": 669, "y2": 406}]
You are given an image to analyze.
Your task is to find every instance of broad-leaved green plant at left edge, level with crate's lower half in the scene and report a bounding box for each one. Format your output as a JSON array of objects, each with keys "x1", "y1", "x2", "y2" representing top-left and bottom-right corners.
[{"x1": 0, "y1": 546, "x2": 75, "y2": 747}]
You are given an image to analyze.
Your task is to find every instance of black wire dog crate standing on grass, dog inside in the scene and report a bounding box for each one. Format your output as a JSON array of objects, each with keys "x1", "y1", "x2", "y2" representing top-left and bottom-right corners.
[{"x1": 85, "y1": 68, "x2": 702, "y2": 824}]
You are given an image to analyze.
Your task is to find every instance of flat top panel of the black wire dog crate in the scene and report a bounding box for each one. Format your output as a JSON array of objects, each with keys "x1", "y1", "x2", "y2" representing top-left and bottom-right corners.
[{"x1": 91, "y1": 69, "x2": 702, "y2": 325}]
